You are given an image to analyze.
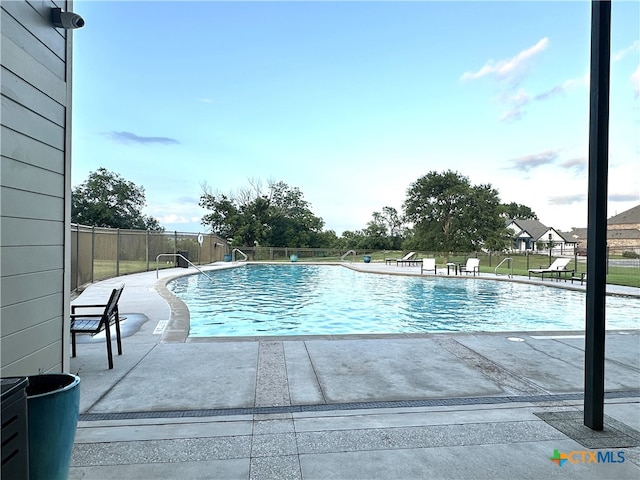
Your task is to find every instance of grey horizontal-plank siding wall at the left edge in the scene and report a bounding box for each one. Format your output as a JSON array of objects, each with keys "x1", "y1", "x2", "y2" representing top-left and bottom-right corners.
[{"x1": 0, "y1": 0, "x2": 71, "y2": 377}]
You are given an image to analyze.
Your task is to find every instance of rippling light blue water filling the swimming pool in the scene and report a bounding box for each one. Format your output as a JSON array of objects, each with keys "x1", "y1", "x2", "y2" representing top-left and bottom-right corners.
[{"x1": 168, "y1": 264, "x2": 640, "y2": 337}]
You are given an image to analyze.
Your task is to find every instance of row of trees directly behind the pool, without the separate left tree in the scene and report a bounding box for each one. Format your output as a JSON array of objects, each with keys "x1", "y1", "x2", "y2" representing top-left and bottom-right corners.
[{"x1": 200, "y1": 170, "x2": 537, "y2": 251}]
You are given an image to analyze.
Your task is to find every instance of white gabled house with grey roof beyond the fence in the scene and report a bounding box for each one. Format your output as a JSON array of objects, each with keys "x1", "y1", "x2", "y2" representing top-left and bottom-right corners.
[{"x1": 507, "y1": 218, "x2": 576, "y2": 254}]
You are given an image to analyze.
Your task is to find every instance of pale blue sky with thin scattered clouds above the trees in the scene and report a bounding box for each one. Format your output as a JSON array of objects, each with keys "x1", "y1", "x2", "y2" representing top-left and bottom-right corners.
[{"x1": 72, "y1": 0, "x2": 640, "y2": 235}]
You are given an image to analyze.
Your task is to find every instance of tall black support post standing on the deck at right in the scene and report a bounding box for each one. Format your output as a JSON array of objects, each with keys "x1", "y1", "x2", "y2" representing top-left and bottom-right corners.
[{"x1": 584, "y1": 0, "x2": 611, "y2": 430}]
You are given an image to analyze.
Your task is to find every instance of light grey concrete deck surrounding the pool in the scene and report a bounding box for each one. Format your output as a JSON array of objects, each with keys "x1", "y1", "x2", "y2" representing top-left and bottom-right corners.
[{"x1": 69, "y1": 264, "x2": 640, "y2": 479}]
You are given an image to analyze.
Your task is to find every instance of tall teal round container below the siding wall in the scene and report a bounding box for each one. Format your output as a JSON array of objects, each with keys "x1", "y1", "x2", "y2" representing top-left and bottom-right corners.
[{"x1": 26, "y1": 373, "x2": 80, "y2": 480}]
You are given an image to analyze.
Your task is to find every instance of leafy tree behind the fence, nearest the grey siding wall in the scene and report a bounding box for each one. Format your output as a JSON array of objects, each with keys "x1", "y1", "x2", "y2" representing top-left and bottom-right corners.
[{"x1": 71, "y1": 168, "x2": 164, "y2": 231}]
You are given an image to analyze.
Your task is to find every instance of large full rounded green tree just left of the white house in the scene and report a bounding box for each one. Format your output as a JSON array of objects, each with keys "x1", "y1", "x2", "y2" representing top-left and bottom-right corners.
[{"x1": 404, "y1": 170, "x2": 509, "y2": 252}]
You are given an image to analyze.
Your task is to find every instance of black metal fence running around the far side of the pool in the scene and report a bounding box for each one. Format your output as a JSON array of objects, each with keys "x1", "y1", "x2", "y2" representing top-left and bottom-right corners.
[{"x1": 71, "y1": 224, "x2": 640, "y2": 291}]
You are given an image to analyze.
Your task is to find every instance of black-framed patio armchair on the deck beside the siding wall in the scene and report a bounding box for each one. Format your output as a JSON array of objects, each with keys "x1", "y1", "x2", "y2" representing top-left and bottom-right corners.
[{"x1": 71, "y1": 283, "x2": 124, "y2": 369}]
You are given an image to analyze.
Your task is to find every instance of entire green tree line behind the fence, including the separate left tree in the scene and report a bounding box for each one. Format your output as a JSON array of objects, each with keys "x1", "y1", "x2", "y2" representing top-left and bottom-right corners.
[{"x1": 72, "y1": 168, "x2": 537, "y2": 252}]
